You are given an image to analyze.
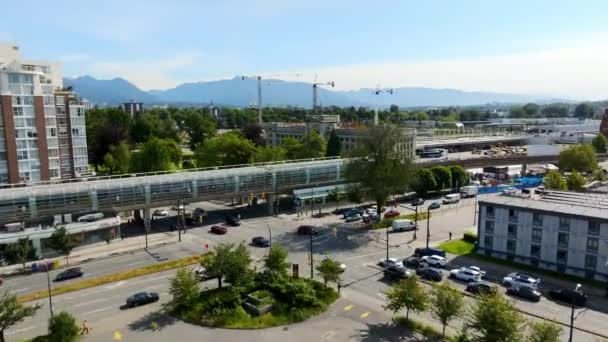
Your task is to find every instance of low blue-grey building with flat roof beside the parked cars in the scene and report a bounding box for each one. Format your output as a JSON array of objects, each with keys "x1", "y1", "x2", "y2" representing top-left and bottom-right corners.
[{"x1": 477, "y1": 192, "x2": 608, "y2": 281}]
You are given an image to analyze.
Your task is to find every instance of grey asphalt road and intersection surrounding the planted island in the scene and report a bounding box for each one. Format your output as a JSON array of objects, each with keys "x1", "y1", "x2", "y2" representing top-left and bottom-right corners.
[{"x1": 7, "y1": 199, "x2": 608, "y2": 341}]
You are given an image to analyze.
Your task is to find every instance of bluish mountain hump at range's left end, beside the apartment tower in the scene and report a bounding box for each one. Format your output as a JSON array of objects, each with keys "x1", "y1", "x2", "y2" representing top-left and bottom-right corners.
[{"x1": 63, "y1": 76, "x2": 158, "y2": 105}]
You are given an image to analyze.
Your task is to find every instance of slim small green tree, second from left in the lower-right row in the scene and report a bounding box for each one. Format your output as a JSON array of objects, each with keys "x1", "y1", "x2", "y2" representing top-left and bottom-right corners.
[{"x1": 431, "y1": 283, "x2": 464, "y2": 337}]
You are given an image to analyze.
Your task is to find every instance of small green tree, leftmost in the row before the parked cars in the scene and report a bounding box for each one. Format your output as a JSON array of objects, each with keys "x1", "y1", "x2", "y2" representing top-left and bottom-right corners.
[{"x1": 384, "y1": 276, "x2": 430, "y2": 319}]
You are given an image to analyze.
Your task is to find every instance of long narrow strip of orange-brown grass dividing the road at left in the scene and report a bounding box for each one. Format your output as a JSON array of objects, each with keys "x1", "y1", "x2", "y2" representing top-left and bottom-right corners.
[{"x1": 17, "y1": 255, "x2": 200, "y2": 303}]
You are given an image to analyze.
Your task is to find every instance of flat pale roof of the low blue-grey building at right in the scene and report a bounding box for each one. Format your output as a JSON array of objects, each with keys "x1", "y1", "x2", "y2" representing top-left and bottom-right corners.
[{"x1": 479, "y1": 191, "x2": 608, "y2": 219}]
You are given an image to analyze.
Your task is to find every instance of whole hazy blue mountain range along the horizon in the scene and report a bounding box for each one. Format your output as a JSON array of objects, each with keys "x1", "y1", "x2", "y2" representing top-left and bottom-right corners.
[{"x1": 63, "y1": 76, "x2": 557, "y2": 108}]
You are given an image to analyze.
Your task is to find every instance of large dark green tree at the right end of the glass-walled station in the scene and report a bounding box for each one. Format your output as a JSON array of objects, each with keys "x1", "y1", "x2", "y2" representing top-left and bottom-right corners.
[{"x1": 345, "y1": 125, "x2": 412, "y2": 214}]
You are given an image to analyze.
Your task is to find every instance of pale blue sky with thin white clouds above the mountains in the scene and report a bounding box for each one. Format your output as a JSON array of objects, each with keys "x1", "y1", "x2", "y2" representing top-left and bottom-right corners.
[{"x1": 0, "y1": 0, "x2": 608, "y2": 100}]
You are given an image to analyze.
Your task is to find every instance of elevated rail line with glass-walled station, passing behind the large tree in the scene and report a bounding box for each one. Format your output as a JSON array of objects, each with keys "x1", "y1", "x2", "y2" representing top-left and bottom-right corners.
[{"x1": 0, "y1": 154, "x2": 607, "y2": 224}]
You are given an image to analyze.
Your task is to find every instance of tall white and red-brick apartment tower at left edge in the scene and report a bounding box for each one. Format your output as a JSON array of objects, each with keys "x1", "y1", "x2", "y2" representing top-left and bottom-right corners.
[{"x1": 0, "y1": 44, "x2": 88, "y2": 184}]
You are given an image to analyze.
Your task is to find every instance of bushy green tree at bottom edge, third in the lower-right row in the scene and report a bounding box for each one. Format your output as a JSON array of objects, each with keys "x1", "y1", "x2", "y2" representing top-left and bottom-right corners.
[{"x1": 467, "y1": 291, "x2": 524, "y2": 342}]
